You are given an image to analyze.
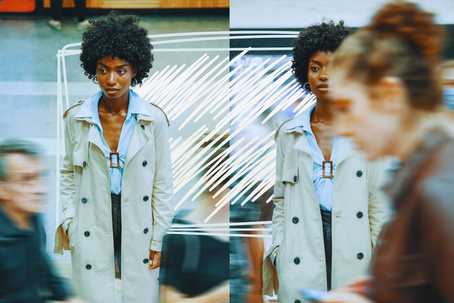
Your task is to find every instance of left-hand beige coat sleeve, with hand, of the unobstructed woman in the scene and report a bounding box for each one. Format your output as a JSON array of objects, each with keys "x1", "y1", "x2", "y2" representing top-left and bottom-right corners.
[{"x1": 54, "y1": 116, "x2": 76, "y2": 253}]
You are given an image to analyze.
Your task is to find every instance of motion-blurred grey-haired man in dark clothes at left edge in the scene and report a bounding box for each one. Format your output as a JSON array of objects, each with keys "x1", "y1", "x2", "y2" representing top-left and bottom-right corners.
[{"x1": 0, "y1": 140, "x2": 76, "y2": 303}]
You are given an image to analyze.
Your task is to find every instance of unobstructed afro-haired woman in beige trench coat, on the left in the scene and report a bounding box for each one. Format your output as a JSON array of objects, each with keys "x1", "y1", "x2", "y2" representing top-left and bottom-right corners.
[{"x1": 56, "y1": 14, "x2": 172, "y2": 303}]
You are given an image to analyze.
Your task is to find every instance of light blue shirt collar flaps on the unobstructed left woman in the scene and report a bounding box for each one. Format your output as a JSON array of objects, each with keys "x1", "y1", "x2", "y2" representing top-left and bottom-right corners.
[{"x1": 75, "y1": 90, "x2": 152, "y2": 125}]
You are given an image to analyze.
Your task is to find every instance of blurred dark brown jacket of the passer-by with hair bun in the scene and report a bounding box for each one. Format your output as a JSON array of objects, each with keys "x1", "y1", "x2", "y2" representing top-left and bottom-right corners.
[{"x1": 372, "y1": 130, "x2": 454, "y2": 303}]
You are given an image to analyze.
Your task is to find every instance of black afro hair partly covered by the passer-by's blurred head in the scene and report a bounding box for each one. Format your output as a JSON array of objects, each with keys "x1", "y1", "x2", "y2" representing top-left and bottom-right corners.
[{"x1": 292, "y1": 21, "x2": 350, "y2": 85}]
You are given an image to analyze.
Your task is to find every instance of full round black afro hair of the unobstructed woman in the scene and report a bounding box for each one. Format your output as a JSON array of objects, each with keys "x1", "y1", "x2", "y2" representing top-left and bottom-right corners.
[{"x1": 80, "y1": 13, "x2": 153, "y2": 86}]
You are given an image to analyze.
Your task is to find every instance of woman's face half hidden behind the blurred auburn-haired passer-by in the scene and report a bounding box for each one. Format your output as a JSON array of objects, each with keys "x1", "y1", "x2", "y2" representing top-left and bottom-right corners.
[{"x1": 307, "y1": 51, "x2": 333, "y2": 100}]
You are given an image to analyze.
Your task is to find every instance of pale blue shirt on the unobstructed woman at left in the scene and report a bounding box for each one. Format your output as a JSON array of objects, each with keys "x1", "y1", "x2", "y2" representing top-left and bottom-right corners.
[{"x1": 84, "y1": 90, "x2": 146, "y2": 194}]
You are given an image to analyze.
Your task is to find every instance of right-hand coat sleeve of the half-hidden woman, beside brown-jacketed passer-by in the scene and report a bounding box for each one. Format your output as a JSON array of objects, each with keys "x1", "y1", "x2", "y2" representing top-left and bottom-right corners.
[{"x1": 367, "y1": 161, "x2": 391, "y2": 247}]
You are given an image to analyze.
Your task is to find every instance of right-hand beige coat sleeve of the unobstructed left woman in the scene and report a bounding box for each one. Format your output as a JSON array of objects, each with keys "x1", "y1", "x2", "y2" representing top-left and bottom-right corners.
[{"x1": 150, "y1": 121, "x2": 173, "y2": 251}]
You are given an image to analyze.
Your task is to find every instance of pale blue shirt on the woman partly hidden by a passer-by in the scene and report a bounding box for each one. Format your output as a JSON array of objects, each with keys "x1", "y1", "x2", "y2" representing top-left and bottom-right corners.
[{"x1": 301, "y1": 104, "x2": 348, "y2": 211}]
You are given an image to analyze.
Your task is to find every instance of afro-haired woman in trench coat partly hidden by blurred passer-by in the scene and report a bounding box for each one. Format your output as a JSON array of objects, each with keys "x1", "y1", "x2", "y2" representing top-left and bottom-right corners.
[{"x1": 264, "y1": 22, "x2": 387, "y2": 303}]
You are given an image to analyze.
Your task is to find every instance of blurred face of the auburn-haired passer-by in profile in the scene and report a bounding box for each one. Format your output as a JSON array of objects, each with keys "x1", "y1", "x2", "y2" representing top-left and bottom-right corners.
[{"x1": 330, "y1": 69, "x2": 406, "y2": 160}]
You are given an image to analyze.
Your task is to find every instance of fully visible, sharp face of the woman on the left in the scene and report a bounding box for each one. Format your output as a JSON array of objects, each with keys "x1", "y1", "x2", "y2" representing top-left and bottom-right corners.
[{"x1": 96, "y1": 57, "x2": 135, "y2": 99}]
